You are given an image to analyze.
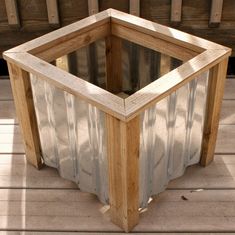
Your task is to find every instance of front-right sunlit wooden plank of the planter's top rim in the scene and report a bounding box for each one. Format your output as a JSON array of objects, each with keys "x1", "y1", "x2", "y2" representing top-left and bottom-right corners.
[{"x1": 125, "y1": 50, "x2": 231, "y2": 121}]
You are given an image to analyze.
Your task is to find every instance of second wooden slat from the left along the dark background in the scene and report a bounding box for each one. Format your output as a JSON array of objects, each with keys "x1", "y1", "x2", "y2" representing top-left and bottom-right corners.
[{"x1": 46, "y1": 0, "x2": 60, "y2": 26}]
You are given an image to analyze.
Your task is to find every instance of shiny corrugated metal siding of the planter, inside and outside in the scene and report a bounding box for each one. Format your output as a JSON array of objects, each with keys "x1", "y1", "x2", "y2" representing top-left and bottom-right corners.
[{"x1": 28, "y1": 41, "x2": 208, "y2": 207}]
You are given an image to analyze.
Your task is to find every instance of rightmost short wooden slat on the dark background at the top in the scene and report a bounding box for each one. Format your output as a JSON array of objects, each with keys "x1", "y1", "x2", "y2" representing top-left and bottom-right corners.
[{"x1": 210, "y1": 0, "x2": 223, "y2": 26}]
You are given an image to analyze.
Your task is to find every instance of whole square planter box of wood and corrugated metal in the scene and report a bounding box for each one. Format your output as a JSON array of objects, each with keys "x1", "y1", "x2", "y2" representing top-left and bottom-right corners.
[{"x1": 4, "y1": 9, "x2": 231, "y2": 231}]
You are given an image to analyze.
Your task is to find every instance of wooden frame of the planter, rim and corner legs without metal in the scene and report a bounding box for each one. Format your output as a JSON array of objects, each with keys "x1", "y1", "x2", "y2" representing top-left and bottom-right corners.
[{"x1": 4, "y1": 9, "x2": 231, "y2": 231}]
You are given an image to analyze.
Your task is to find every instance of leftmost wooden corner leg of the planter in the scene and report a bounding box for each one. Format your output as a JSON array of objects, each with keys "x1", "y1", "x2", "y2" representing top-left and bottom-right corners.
[{"x1": 8, "y1": 63, "x2": 42, "y2": 168}]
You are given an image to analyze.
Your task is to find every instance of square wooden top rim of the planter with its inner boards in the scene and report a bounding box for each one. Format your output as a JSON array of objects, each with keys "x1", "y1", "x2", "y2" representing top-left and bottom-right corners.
[{"x1": 4, "y1": 9, "x2": 231, "y2": 121}]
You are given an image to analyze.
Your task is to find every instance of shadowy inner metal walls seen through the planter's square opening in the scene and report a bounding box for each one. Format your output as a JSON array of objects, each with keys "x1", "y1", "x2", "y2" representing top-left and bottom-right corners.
[{"x1": 53, "y1": 38, "x2": 182, "y2": 98}]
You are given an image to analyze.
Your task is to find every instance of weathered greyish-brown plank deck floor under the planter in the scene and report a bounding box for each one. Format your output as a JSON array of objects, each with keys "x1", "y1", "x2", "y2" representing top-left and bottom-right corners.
[{"x1": 0, "y1": 79, "x2": 235, "y2": 235}]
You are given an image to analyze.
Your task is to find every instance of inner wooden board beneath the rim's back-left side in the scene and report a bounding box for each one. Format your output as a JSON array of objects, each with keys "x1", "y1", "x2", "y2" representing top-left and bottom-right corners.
[{"x1": 33, "y1": 23, "x2": 110, "y2": 62}]
